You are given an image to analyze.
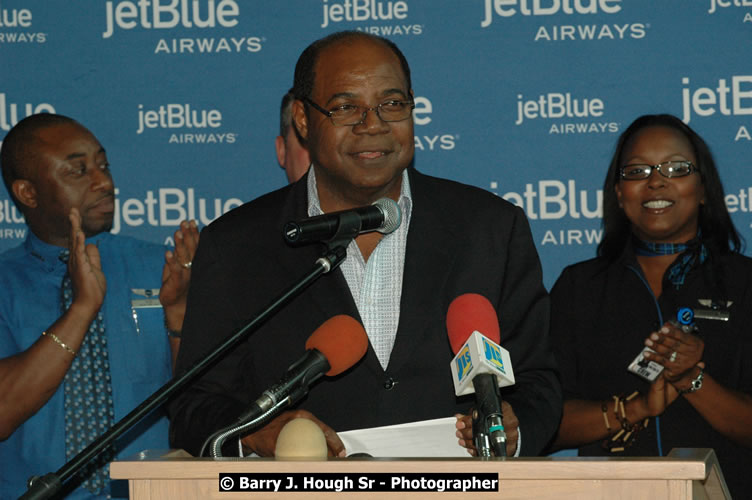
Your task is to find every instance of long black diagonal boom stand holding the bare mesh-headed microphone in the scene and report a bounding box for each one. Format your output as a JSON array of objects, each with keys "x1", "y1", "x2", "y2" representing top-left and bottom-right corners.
[{"x1": 19, "y1": 219, "x2": 361, "y2": 500}]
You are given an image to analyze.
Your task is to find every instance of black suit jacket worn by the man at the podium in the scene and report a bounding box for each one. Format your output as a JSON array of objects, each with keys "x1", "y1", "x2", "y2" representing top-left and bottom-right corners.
[{"x1": 171, "y1": 168, "x2": 561, "y2": 455}]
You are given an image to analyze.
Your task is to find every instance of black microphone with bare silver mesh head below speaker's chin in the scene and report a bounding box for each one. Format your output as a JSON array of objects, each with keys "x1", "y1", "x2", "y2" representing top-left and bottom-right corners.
[{"x1": 284, "y1": 198, "x2": 402, "y2": 244}]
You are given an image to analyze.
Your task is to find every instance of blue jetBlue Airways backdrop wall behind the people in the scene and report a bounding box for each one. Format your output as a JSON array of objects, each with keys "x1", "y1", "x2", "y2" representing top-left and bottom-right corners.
[{"x1": 0, "y1": 0, "x2": 752, "y2": 287}]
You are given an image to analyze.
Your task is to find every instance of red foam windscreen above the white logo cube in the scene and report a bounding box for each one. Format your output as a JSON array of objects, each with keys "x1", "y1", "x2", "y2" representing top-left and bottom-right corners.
[{"x1": 447, "y1": 293, "x2": 501, "y2": 354}]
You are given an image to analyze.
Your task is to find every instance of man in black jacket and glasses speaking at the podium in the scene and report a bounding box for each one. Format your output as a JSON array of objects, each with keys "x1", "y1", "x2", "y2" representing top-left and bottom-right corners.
[{"x1": 170, "y1": 31, "x2": 561, "y2": 456}]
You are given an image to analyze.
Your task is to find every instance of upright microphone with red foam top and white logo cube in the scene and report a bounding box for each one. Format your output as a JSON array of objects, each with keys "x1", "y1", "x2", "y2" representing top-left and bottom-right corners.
[{"x1": 446, "y1": 293, "x2": 514, "y2": 456}]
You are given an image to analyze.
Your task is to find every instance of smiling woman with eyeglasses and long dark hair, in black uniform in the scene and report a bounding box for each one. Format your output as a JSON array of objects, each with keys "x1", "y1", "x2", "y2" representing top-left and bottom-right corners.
[{"x1": 551, "y1": 115, "x2": 752, "y2": 498}]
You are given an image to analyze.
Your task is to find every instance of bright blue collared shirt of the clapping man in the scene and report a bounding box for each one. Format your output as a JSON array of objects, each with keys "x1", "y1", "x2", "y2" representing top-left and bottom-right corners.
[{"x1": 0, "y1": 232, "x2": 171, "y2": 500}]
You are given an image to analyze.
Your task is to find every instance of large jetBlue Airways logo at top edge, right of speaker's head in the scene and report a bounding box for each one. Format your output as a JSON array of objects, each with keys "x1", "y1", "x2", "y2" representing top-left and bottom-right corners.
[{"x1": 480, "y1": 0, "x2": 649, "y2": 42}]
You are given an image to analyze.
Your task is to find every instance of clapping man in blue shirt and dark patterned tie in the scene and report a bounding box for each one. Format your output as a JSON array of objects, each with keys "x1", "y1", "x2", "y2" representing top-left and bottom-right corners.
[{"x1": 0, "y1": 114, "x2": 198, "y2": 499}]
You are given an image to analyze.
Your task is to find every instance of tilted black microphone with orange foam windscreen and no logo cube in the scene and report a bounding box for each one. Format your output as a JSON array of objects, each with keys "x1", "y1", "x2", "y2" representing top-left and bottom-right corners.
[{"x1": 238, "y1": 314, "x2": 368, "y2": 422}]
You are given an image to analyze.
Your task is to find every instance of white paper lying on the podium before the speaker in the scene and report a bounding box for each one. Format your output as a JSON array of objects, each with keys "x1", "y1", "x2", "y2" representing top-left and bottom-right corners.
[{"x1": 337, "y1": 417, "x2": 470, "y2": 458}]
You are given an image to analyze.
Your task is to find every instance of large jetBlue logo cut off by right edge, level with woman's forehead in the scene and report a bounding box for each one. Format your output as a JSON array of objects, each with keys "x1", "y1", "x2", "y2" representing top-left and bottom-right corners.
[{"x1": 682, "y1": 75, "x2": 752, "y2": 142}]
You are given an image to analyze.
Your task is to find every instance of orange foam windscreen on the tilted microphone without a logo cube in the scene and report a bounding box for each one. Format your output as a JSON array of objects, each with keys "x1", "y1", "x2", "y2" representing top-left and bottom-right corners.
[{"x1": 306, "y1": 314, "x2": 368, "y2": 377}]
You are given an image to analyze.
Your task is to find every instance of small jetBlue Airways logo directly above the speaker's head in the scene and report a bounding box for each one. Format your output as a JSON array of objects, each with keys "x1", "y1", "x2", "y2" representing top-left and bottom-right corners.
[{"x1": 321, "y1": 0, "x2": 423, "y2": 36}]
